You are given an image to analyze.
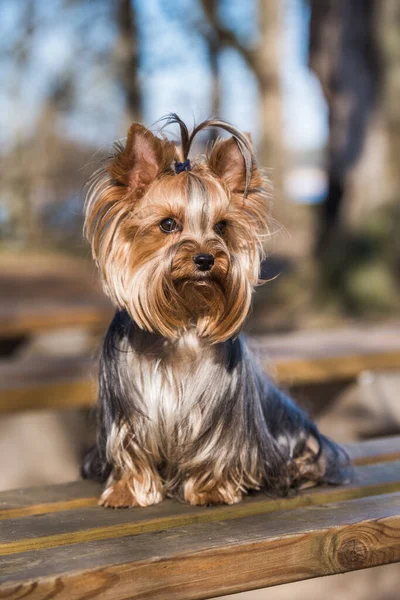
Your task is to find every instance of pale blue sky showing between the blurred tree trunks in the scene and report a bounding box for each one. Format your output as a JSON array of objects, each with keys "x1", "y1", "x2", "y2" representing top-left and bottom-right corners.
[{"x1": 0, "y1": 0, "x2": 327, "y2": 151}]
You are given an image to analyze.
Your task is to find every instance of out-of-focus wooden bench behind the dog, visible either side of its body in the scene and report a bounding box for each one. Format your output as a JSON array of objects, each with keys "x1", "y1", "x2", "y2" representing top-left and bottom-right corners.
[{"x1": 0, "y1": 323, "x2": 400, "y2": 412}]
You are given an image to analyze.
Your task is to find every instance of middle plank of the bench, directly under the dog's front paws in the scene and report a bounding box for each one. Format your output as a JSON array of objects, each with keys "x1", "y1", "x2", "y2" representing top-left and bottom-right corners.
[{"x1": 0, "y1": 461, "x2": 400, "y2": 556}]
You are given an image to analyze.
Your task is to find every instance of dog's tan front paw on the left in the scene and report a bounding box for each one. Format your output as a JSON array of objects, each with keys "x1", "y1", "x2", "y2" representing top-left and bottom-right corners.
[{"x1": 99, "y1": 477, "x2": 163, "y2": 508}]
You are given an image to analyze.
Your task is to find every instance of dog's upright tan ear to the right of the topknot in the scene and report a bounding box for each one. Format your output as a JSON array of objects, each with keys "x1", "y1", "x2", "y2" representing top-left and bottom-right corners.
[{"x1": 208, "y1": 134, "x2": 261, "y2": 192}]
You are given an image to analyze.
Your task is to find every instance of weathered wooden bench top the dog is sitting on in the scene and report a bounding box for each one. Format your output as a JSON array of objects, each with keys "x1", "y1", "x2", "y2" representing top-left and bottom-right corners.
[{"x1": 0, "y1": 437, "x2": 400, "y2": 600}]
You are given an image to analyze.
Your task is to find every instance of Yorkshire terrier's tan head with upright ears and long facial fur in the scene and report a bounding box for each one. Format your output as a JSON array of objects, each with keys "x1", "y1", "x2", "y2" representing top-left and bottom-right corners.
[{"x1": 86, "y1": 124, "x2": 268, "y2": 342}]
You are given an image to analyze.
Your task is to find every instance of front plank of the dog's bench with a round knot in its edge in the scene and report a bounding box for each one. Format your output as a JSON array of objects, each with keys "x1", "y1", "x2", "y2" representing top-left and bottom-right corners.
[{"x1": 0, "y1": 493, "x2": 400, "y2": 600}]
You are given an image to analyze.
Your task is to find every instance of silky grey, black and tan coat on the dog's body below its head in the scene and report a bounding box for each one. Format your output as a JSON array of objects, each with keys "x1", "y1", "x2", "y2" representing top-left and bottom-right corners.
[{"x1": 82, "y1": 311, "x2": 350, "y2": 498}]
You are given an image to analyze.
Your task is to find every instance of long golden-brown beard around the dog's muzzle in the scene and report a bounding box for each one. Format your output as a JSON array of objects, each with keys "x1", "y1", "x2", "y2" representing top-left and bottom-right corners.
[{"x1": 123, "y1": 252, "x2": 252, "y2": 343}]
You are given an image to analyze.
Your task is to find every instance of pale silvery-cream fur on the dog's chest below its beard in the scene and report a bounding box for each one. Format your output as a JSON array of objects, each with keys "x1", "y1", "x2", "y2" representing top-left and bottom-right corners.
[{"x1": 131, "y1": 333, "x2": 227, "y2": 443}]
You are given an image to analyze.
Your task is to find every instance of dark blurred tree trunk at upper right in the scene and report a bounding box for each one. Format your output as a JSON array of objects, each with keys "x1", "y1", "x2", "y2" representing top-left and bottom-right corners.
[{"x1": 310, "y1": 0, "x2": 380, "y2": 254}]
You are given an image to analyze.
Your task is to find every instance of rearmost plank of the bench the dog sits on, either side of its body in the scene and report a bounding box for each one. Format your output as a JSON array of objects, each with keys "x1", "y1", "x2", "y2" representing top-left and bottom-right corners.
[{"x1": 0, "y1": 436, "x2": 400, "y2": 520}]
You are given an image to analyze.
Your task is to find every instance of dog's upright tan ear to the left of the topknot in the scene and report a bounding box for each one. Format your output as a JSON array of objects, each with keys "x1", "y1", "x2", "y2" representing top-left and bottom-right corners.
[{"x1": 109, "y1": 123, "x2": 175, "y2": 195}]
